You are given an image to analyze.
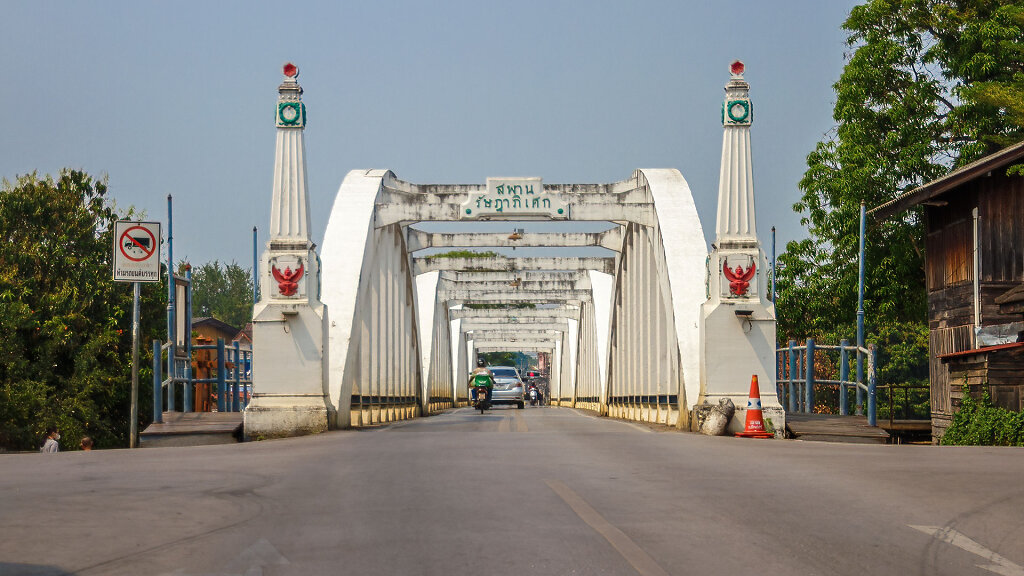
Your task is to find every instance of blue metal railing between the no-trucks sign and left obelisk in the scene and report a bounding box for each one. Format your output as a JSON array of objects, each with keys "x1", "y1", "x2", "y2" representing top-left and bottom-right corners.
[{"x1": 153, "y1": 338, "x2": 253, "y2": 423}]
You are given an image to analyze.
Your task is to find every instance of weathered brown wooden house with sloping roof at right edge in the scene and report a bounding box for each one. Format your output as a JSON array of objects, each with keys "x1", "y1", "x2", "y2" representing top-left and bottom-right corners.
[{"x1": 871, "y1": 142, "x2": 1024, "y2": 441}]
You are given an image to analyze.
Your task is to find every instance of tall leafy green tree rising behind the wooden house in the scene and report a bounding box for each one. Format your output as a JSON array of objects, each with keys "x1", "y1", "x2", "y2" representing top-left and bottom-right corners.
[{"x1": 776, "y1": 0, "x2": 1024, "y2": 393}]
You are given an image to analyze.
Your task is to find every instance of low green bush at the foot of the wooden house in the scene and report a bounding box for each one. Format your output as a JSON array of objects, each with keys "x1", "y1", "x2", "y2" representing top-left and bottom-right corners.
[{"x1": 942, "y1": 385, "x2": 1024, "y2": 446}]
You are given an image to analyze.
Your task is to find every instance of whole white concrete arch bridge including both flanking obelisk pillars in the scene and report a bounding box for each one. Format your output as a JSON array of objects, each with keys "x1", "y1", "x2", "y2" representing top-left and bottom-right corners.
[{"x1": 244, "y1": 61, "x2": 784, "y2": 438}]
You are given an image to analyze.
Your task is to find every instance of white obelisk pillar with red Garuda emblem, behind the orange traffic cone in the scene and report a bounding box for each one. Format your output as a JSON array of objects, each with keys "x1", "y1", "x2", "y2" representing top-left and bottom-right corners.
[{"x1": 695, "y1": 60, "x2": 785, "y2": 434}]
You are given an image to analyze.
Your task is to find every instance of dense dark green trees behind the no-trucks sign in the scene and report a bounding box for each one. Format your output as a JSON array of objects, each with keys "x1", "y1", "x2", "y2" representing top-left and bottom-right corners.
[{"x1": 0, "y1": 170, "x2": 166, "y2": 450}]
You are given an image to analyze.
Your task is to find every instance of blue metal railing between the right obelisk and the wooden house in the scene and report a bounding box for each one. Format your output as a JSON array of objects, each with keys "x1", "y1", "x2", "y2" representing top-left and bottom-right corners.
[{"x1": 775, "y1": 338, "x2": 879, "y2": 426}]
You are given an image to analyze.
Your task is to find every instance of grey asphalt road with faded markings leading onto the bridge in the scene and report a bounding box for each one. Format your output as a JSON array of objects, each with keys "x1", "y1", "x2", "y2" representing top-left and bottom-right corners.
[{"x1": 0, "y1": 407, "x2": 1024, "y2": 576}]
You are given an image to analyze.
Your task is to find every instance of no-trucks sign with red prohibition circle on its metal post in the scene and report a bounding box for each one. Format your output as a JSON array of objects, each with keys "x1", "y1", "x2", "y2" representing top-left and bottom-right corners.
[{"x1": 114, "y1": 220, "x2": 160, "y2": 448}]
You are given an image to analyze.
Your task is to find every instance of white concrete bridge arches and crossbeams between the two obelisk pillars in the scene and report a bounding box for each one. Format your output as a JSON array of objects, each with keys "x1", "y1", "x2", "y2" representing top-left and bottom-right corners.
[{"x1": 321, "y1": 169, "x2": 708, "y2": 427}]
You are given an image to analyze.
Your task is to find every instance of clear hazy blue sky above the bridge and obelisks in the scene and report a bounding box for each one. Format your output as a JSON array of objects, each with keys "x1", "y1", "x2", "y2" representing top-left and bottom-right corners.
[{"x1": 0, "y1": 0, "x2": 856, "y2": 266}]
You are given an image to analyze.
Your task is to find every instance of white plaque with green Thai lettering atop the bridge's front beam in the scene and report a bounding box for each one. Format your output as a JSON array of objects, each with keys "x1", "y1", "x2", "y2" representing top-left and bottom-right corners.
[{"x1": 459, "y1": 178, "x2": 569, "y2": 220}]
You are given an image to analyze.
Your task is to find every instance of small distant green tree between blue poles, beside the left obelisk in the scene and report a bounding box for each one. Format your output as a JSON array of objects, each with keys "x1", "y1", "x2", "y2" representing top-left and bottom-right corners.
[{"x1": 178, "y1": 260, "x2": 253, "y2": 328}]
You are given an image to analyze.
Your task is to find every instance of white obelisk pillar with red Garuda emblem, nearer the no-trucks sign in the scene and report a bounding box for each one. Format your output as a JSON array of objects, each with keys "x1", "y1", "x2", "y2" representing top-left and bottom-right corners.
[{"x1": 245, "y1": 64, "x2": 335, "y2": 438}]
